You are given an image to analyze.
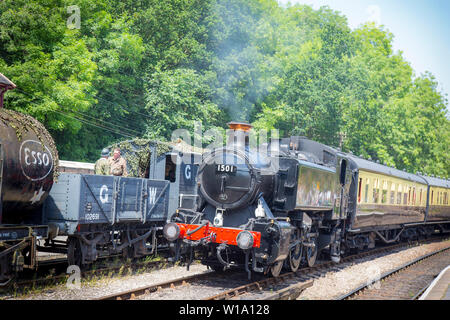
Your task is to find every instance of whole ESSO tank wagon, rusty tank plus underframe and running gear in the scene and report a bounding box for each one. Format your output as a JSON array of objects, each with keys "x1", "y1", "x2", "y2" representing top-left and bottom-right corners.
[{"x1": 0, "y1": 74, "x2": 58, "y2": 286}]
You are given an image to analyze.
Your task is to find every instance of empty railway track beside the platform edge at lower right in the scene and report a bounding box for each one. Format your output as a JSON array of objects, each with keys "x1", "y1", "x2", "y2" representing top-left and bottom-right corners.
[{"x1": 337, "y1": 247, "x2": 450, "y2": 300}]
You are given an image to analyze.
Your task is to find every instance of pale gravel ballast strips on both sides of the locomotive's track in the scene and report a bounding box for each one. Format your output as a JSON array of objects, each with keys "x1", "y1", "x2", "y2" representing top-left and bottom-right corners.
[{"x1": 4, "y1": 240, "x2": 450, "y2": 300}]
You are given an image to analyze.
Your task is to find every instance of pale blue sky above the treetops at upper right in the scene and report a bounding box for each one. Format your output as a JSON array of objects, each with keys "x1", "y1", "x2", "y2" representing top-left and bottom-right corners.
[{"x1": 278, "y1": 0, "x2": 450, "y2": 109}]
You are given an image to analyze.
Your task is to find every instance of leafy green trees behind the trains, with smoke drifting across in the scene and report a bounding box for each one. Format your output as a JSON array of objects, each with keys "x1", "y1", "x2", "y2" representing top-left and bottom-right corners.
[{"x1": 0, "y1": 0, "x2": 450, "y2": 176}]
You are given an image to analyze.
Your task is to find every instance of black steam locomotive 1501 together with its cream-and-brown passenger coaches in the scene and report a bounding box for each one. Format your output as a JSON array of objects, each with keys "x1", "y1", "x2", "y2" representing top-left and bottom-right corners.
[{"x1": 164, "y1": 123, "x2": 450, "y2": 277}]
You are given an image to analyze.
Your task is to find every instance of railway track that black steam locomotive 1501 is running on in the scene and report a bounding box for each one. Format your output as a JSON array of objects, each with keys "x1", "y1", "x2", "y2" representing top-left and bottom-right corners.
[{"x1": 98, "y1": 239, "x2": 442, "y2": 300}]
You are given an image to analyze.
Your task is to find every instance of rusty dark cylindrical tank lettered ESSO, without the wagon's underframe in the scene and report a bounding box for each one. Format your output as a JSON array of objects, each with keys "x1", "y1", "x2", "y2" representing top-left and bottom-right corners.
[{"x1": 0, "y1": 109, "x2": 58, "y2": 224}]
